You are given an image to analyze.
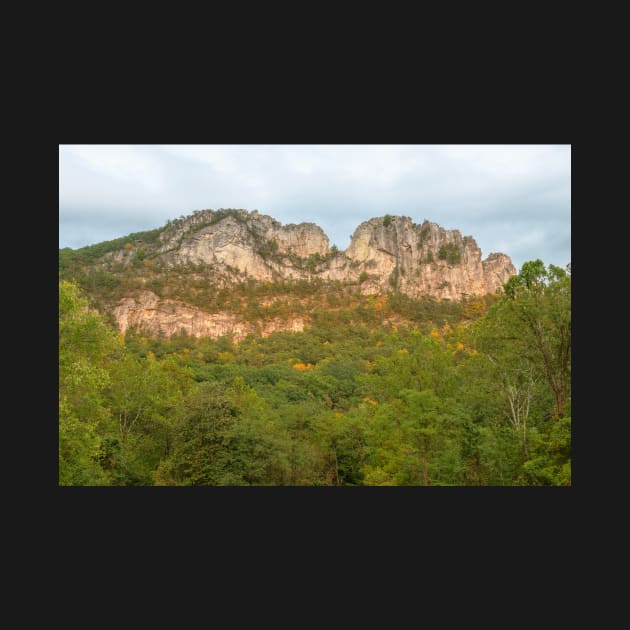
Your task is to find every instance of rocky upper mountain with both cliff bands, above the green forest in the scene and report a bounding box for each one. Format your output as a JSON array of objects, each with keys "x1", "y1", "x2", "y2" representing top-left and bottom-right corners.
[{"x1": 59, "y1": 210, "x2": 516, "y2": 341}]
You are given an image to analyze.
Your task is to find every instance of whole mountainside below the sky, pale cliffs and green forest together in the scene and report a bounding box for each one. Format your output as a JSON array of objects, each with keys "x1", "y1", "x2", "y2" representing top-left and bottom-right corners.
[{"x1": 59, "y1": 210, "x2": 571, "y2": 486}]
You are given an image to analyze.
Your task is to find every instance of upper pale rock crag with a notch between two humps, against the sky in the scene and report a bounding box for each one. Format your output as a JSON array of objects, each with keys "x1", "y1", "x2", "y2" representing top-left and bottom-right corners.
[{"x1": 139, "y1": 210, "x2": 516, "y2": 300}]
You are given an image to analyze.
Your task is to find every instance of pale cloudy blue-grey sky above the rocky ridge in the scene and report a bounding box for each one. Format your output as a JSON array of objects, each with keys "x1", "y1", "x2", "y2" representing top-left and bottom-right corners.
[{"x1": 59, "y1": 145, "x2": 571, "y2": 268}]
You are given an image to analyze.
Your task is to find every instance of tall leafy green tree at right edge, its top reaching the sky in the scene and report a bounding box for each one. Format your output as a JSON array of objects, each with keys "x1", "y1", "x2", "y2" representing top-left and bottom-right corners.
[{"x1": 462, "y1": 260, "x2": 571, "y2": 485}]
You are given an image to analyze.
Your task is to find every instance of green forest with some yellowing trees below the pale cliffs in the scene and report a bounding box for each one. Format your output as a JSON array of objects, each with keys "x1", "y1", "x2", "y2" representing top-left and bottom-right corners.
[{"x1": 59, "y1": 260, "x2": 571, "y2": 486}]
